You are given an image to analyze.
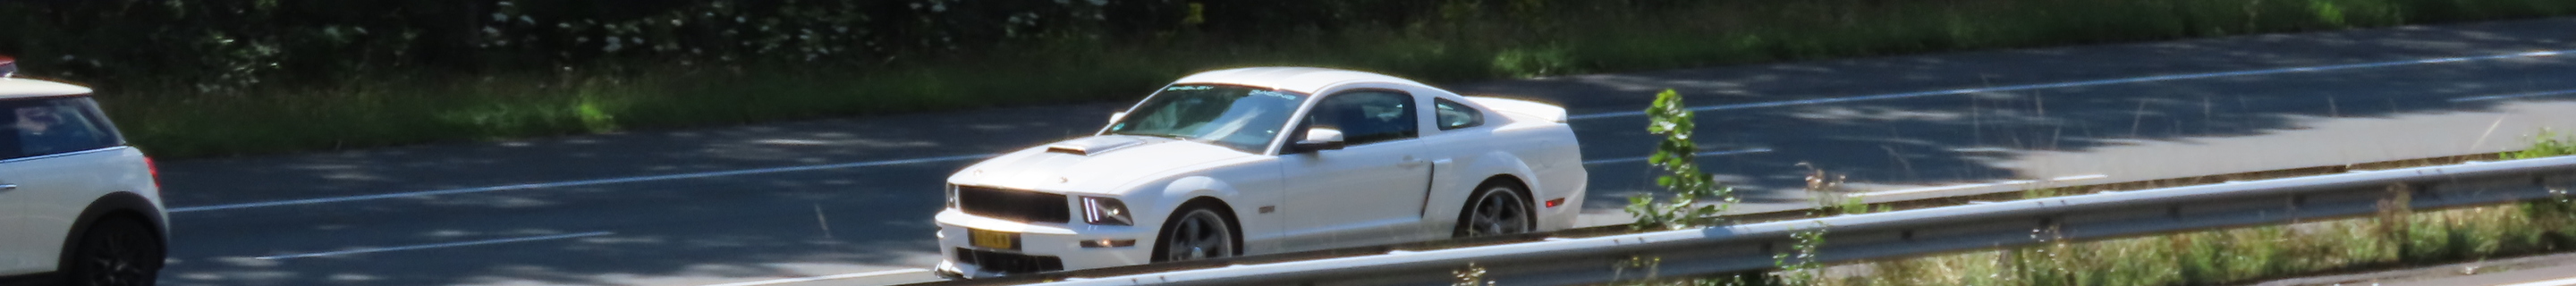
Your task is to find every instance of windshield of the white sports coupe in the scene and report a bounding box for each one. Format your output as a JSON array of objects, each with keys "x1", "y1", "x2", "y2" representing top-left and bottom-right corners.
[{"x1": 1107, "y1": 85, "x2": 1306, "y2": 152}]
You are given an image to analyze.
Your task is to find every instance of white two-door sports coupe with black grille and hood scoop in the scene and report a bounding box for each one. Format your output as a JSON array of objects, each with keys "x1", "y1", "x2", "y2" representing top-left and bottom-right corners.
[{"x1": 935, "y1": 67, "x2": 1584, "y2": 278}]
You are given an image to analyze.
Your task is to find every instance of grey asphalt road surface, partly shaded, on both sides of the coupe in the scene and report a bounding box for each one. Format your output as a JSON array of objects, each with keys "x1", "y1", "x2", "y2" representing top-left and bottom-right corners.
[{"x1": 160, "y1": 18, "x2": 2576, "y2": 286}]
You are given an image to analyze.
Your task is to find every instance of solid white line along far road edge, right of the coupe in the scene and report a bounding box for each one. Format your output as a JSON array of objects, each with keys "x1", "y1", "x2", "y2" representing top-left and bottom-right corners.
[{"x1": 1566, "y1": 49, "x2": 2576, "y2": 119}]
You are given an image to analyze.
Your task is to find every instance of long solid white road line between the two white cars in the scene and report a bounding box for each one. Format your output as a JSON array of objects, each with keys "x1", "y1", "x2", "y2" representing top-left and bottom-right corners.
[{"x1": 170, "y1": 155, "x2": 997, "y2": 211}]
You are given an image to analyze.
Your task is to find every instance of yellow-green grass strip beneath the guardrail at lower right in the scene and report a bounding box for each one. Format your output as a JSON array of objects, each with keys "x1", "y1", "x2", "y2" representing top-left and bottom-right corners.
[{"x1": 1824, "y1": 204, "x2": 2565, "y2": 286}]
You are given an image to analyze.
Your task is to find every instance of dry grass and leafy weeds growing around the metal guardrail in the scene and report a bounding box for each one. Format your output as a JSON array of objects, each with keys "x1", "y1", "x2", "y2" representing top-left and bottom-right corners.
[{"x1": 1597, "y1": 131, "x2": 2576, "y2": 286}]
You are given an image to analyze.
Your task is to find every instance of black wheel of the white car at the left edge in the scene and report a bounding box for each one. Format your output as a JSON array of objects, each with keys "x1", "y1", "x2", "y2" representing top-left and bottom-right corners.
[{"x1": 62, "y1": 216, "x2": 167, "y2": 286}]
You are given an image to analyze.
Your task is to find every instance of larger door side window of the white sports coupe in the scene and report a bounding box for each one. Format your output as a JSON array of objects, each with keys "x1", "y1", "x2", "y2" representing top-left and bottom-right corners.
[{"x1": 1306, "y1": 90, "x2": 1419, "y2": 144}]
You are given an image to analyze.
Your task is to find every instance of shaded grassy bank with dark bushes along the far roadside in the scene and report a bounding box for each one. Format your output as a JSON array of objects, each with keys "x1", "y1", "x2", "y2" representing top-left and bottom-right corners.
[{"x1": 0, "y1": 0, "x2": 2576, "y2": 157}]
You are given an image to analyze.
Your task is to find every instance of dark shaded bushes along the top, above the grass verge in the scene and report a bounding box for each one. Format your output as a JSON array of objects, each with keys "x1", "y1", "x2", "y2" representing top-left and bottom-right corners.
[{"x1": 0, "y1": 0, "x2": 1672, "y2": 88}]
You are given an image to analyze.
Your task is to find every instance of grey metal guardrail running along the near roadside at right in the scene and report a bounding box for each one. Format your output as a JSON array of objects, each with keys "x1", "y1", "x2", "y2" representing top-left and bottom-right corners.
[{"x1": 1009, "y1": 157, "x2": 2576, "y2": 286}]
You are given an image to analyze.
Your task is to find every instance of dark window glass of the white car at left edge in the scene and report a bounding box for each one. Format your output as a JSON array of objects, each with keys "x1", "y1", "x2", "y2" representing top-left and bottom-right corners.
[{"x1": 0, "y1": 96, "x2": 123, "y2": 160}]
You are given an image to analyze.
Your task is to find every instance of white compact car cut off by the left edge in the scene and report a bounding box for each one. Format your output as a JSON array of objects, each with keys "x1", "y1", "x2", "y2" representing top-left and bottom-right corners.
[{"x1": 0, "y1": 56, "x2": 167, "y2": 286}]
